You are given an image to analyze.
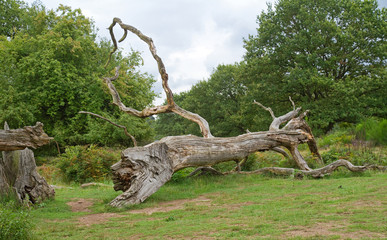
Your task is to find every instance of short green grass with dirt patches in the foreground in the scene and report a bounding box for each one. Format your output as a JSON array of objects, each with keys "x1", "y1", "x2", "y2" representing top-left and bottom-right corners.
[{"x1": 30, "y1": 171, "x2": 387, "y2": 239}]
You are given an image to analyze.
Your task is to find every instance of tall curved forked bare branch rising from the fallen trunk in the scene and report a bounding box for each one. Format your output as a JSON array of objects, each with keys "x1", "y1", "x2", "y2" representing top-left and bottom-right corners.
[{"x1": 104, "y1": 18, "x2": 212, "y2": 138}]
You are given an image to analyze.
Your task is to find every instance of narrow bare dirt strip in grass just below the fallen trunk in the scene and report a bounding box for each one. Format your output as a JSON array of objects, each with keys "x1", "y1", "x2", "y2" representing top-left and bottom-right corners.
[{"x1": 129, "y1": 196, "x2": 211, "y2": 215}]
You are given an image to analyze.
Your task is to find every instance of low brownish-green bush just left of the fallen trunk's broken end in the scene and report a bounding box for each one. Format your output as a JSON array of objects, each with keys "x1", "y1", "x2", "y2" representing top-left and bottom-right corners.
[{"x1": 56, "y1": 145, "x2": 120, "y2": 183}]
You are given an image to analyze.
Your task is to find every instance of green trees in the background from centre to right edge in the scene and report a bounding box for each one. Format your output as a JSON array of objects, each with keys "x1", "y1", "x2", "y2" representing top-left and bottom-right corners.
[{"x1": 157, "y1": 0, "x2": 387, "y2": 136}]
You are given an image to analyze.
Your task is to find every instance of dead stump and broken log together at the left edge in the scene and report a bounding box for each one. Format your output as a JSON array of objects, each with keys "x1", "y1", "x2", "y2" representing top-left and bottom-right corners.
[{"x1": 0, "y1": 123, "x2": 55, "y2": 203}]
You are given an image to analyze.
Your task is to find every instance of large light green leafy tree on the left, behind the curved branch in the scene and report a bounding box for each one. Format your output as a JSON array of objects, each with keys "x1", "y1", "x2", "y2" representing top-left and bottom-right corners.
[{"x1": 0, "y1": 5, "x2": 155, "y2": 145}]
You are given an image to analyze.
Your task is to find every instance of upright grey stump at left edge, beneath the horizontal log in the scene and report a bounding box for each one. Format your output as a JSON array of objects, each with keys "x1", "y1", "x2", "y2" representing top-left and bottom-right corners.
[{"x1": 0, "y1": 125, "x2": 55, "y2": 203}]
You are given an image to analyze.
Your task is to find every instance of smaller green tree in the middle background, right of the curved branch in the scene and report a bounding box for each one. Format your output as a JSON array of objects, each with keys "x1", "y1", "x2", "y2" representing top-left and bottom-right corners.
[{"x1": 156, "y1": 64, "x2": 247, "y2": 137}]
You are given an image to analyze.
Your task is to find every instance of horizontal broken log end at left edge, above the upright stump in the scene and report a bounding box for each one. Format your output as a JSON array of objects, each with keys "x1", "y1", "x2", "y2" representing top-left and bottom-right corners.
[{"x1": 0, "y1": 122, "x2": 53, "y2": 151}]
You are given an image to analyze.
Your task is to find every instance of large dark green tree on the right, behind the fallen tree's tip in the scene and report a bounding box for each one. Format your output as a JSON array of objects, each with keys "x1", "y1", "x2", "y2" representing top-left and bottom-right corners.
[{"x1": 243, "y1": 0, "x2": 387, "y2": 131}]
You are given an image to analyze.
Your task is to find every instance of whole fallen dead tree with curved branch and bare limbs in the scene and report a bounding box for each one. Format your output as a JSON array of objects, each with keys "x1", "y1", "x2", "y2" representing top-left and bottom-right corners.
[{"x1": 104, "y1": 18, "x2": 378, "y2": 207}]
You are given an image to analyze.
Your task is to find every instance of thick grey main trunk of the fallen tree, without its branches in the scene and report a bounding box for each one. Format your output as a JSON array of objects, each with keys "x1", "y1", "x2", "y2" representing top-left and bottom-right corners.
[{"x1": 110, "y1": 131, "x2": 308, "y2": 207}]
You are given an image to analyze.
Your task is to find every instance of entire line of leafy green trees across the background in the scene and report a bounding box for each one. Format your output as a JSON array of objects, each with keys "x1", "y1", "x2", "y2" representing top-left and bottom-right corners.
[{"x1": 0, "y1": 0, "x2": 387, "y2": 151}]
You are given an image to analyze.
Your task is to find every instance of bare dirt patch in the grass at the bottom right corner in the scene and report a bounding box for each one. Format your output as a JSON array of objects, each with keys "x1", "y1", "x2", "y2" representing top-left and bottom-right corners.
[{"x1": 285, "y1": 222, "x2": 386, "y2": 239}]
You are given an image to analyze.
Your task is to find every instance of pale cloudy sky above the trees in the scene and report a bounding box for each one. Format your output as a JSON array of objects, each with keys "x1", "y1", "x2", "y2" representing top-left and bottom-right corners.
[{"x1": 25, "y1": 0, "x2": 387, "y2": 105}]
